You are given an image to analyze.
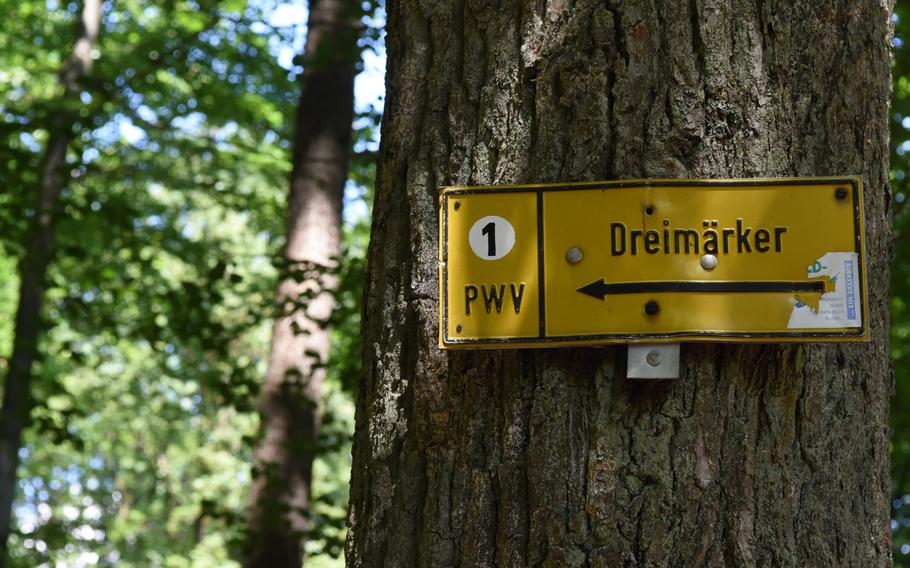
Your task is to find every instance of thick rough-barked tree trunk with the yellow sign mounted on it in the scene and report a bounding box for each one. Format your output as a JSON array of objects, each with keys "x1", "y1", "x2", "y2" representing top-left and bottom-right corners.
[{"x1": 347, "y1": 0, "x2": 891, "y2": 567}]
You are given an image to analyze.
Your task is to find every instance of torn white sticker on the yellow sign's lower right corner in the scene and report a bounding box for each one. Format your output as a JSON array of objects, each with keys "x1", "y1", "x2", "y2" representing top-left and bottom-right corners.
[{"x1": 787, "y1": 252, "x2": 863, "y2": 329}]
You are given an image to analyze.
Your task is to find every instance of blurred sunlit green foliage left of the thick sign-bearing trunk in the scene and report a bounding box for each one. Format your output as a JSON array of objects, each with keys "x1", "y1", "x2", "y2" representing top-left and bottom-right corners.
[{"x1": 0, "y1": 0, "x2": 372, "y2": 567}]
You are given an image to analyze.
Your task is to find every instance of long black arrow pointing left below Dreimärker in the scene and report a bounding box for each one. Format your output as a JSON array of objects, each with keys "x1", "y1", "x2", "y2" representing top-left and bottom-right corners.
[{"x1": 578, "y1": 278, "x2": 825, "y2": 300}]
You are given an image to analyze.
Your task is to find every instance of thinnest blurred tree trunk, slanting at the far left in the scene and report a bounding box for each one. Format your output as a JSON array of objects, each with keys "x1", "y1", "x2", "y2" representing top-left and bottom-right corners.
[{"x1": 0, "y1": 0, "x2": 101, "y2": 568}]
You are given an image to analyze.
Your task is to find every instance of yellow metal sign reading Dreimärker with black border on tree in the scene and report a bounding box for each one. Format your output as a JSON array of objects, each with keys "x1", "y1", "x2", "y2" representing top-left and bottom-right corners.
[{"x1": 439, "y1": 177, "x2": 868, "y2": 348}]
